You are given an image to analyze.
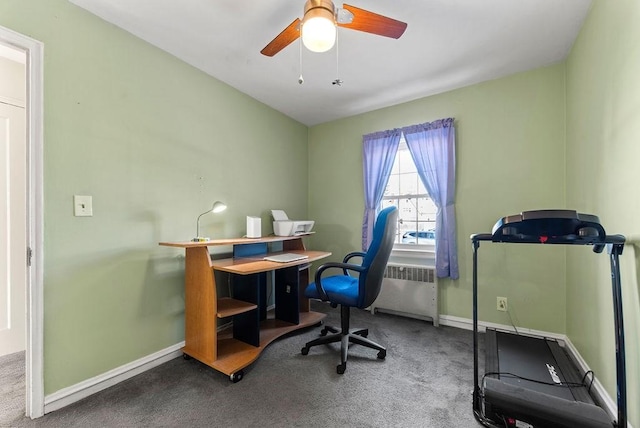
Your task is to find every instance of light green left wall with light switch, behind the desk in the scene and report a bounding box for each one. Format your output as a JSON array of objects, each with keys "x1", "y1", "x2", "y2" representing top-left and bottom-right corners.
[{"x1": 0, "y1": 0, "x2": 308, "y2": 394}]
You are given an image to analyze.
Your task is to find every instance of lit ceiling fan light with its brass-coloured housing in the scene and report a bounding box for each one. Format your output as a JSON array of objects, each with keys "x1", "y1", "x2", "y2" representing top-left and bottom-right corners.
[{"x1": 302, "y1": 0, "x2": 336, "y2": 52}]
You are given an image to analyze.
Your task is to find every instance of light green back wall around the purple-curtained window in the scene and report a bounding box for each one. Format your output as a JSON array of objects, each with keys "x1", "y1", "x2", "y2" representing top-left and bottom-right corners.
[{"x1": 309, "y1": 64, "x2": 565, "y2": 332}]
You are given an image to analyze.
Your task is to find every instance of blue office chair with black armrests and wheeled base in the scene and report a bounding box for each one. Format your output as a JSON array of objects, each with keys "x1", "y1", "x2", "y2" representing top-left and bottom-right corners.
[{"x1": 302, "y1": 207, "x2": 398, "y2": 374}]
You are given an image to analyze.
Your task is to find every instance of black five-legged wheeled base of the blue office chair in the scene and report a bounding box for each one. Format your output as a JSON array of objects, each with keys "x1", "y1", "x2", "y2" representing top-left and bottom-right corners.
[{"x1": 301, "y1": 306, "x2": 387, "y2": 374}]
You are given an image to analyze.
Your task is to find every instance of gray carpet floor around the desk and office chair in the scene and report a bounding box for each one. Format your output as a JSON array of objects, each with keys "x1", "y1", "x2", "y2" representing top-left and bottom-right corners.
[{"x1": 0, "y1": 302, "x2": 479, "y2": 428}]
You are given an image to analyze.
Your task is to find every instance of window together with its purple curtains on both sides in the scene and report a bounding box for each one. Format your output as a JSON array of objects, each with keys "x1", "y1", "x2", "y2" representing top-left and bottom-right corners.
[{"x1": 362, "y1": 117, "x2": 459, "y2": 279}]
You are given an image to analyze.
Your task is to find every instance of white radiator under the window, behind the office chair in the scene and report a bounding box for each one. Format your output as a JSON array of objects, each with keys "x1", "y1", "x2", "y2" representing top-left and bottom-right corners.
[{"x1": 369, "y1": 264, "x2": 439, "y2": 327}]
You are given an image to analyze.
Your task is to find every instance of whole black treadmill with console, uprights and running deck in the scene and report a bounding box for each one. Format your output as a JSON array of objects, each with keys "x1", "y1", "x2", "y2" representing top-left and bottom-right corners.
[{"x1": 471, "y1": 210, "x2": 627, "y2": 428}]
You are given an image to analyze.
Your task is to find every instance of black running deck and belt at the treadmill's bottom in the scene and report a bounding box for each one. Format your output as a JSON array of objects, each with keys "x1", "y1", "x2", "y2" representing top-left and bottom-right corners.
[{"x1": 483, "y1": 329, "x2": 612, "y2": 428}]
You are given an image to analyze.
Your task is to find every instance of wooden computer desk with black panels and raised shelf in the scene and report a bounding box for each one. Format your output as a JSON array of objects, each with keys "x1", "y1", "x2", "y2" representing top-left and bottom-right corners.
[{"x1": 160, "y1": 236, "x2": 331, "y2": 382}]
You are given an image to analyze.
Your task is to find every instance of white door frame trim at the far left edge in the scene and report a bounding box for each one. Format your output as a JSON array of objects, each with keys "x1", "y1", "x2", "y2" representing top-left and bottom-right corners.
[{"x1": 0, "y1": 27, "x2": 44, "y2": 418}]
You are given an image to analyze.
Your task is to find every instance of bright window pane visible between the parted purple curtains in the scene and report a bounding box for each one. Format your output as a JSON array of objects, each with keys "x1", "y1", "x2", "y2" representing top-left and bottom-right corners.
[{"x1": 380, "y1": 137, "x2": 437, "y2": 250}]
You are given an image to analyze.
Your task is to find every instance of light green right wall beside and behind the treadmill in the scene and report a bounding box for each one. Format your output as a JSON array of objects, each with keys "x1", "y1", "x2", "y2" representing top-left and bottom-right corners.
[{"x1": 567, "y1": 0, "x2": 640, "y2": 427}]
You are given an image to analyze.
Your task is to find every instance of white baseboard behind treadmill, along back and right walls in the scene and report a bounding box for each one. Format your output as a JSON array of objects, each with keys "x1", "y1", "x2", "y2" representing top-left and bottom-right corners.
[{"x1": 440, "y1": 315, "x2": 633, "y2": 428}]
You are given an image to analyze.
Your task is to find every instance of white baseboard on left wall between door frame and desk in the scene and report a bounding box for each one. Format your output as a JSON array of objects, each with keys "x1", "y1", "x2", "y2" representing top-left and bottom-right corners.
[{"x1": 44, "y1": 341, "x2": 184, "y2": 413}]
